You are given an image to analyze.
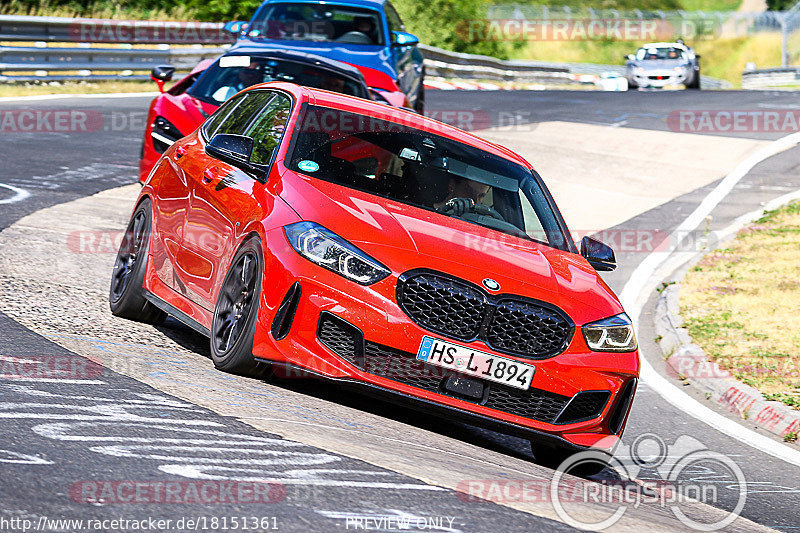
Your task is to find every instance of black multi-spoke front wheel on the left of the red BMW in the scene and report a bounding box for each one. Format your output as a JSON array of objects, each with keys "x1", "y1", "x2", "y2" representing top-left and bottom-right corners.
[{"x1": 211, "y1": 237, "x2": 270, "y2": 377}]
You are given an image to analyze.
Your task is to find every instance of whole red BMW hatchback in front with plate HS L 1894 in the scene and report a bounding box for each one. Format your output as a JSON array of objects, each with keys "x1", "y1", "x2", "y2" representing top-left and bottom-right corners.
[{"x1": 110, "y1": 83, "x2": 639, "y2": 468}]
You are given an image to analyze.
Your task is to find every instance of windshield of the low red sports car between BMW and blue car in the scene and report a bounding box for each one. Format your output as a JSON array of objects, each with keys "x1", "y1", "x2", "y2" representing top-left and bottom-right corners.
[{"x1": 187, "y1": 55, "x2": 368, "y2": 105}]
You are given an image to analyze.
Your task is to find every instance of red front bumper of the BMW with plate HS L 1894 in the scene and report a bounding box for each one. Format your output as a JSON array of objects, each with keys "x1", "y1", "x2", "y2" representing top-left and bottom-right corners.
[{"x1": 253, "y1": 228, "x2": 639, "y2": 450}]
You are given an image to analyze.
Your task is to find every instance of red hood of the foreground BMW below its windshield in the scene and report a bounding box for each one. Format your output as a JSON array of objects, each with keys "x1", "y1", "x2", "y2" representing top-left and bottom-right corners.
[{"x1": 280, "y1": 175, "x2": 622, "y2": 325}]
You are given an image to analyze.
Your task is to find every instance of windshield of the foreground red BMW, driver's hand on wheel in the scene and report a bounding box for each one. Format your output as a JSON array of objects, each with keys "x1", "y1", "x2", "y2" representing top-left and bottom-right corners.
[{"x1": 286, "y1": 106, "x2": 568, "y2": 250}]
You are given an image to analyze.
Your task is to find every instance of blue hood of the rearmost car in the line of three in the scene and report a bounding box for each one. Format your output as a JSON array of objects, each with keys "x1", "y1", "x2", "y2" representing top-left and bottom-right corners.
[{"x1": 229, "y1": 37, "x2": 397, "y2": 80}]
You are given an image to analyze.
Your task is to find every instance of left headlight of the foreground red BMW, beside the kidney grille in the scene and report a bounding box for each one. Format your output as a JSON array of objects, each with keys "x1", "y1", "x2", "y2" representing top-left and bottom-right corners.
[{"x1": 283, "y1": 222, "x2": 391, "y2": 285}]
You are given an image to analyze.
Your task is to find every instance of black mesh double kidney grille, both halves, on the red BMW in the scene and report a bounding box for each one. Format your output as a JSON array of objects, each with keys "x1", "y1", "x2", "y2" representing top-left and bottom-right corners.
[{"x1": 397, "y1": 272, "x2": 574, "y2": 359}]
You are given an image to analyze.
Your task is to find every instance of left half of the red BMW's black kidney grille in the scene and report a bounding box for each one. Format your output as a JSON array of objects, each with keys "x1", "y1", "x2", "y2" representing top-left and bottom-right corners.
[{"x1": 399, "y1": 274, "x2": 486, "y2": 339}]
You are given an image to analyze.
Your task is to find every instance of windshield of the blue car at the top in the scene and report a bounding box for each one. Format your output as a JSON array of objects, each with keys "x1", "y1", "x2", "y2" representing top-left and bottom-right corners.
[{"x1": 247, "y1": 3, "x2": 384, "y2": 45}]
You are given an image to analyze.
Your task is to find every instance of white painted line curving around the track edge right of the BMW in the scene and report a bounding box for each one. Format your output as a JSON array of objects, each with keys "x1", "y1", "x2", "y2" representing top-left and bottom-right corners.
[{"x1": 620, "y1": 133, "x2": 800, "y2": 466}]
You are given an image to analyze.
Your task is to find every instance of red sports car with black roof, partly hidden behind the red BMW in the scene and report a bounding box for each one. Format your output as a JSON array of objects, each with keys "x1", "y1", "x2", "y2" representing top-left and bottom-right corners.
[{"x1": 139, "y1": 47, "x2": 380, "y2": 183}]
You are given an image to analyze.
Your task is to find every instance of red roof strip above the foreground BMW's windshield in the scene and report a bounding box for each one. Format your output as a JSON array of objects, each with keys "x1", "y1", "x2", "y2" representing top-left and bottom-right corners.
[{"x1": 256, "y1": 82, "x2": 532, "y2": 168}]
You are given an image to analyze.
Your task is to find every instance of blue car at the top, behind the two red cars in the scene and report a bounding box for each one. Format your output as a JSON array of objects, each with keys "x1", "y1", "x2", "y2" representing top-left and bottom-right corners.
[{"x1": 225, "y1": 0, "x2": 425, "y2": 113}]
